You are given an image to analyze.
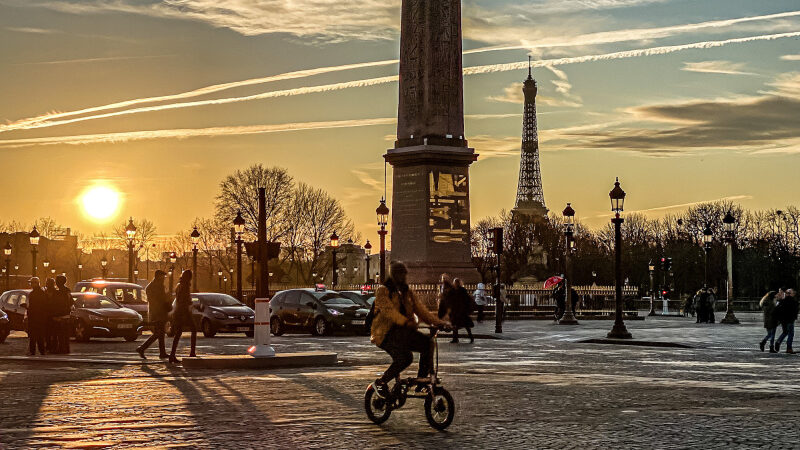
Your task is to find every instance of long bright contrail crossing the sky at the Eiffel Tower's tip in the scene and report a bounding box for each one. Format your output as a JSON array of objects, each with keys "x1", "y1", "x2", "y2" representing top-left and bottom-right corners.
[{"x1": 0, "y1": 32, "x2": 800, "y2": 132}]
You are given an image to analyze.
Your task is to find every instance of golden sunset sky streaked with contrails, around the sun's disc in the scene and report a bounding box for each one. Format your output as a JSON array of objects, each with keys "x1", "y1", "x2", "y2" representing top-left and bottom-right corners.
[{"x1": 0, "y1": 0, "x2": 800, "y2": 241}]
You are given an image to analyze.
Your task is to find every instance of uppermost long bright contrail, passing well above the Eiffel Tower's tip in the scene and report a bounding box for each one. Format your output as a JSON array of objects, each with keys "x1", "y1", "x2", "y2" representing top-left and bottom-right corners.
[{"x1": 0, "y1": 11, "x2": 800, "y2": 132}]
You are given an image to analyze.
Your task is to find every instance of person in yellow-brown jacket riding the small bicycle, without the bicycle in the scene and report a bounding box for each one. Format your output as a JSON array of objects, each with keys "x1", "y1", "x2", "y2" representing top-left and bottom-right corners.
[{"x1": 370, "y1": 262, "x2": 449, "y2": 397}]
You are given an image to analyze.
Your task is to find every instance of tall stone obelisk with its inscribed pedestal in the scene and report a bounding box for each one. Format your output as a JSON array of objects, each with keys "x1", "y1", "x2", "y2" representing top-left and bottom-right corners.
[{"x1": 384, "y1": 0, "x2": 478, "y2": 283}]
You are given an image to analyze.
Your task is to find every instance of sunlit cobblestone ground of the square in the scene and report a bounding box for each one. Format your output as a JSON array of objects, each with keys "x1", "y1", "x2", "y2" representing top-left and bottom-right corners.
[{"x1": 0, "y1": 315, "x2": 800, "y2": 449}]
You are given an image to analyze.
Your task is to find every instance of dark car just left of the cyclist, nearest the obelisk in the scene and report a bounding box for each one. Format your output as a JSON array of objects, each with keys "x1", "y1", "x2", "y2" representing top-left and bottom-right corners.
[{"x1": 269, "y1": 289, "x2": 369, "y2": 336}]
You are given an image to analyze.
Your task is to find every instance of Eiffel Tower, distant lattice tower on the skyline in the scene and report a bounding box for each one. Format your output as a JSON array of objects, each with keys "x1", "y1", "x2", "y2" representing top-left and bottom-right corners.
[{"x1": 511, "y1": 56, "x2": 547, "y2": 218}]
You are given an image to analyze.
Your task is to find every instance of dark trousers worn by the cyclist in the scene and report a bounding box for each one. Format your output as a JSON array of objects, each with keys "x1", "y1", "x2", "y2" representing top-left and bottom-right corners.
[{"x1": 380, "y1": 326, "x2": 433, "y2": 383}]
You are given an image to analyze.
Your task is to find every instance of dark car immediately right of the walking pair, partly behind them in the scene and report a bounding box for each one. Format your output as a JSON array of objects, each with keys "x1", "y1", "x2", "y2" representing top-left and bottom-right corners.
[{"x1": 166, "y1": 292, "x2": 255, "y2": 337}]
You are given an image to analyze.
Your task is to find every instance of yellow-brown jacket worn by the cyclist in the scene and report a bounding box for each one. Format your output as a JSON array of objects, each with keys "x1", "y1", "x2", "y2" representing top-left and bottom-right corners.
[{"x1": 370, "y1": 286, "x2": 443, "y2": 346}]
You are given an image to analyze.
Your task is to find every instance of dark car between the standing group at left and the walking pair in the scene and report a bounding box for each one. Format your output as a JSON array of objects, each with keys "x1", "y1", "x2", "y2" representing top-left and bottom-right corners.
[{"x1": 70, "y1": 292, "x2": 143, "y2": 342}]
